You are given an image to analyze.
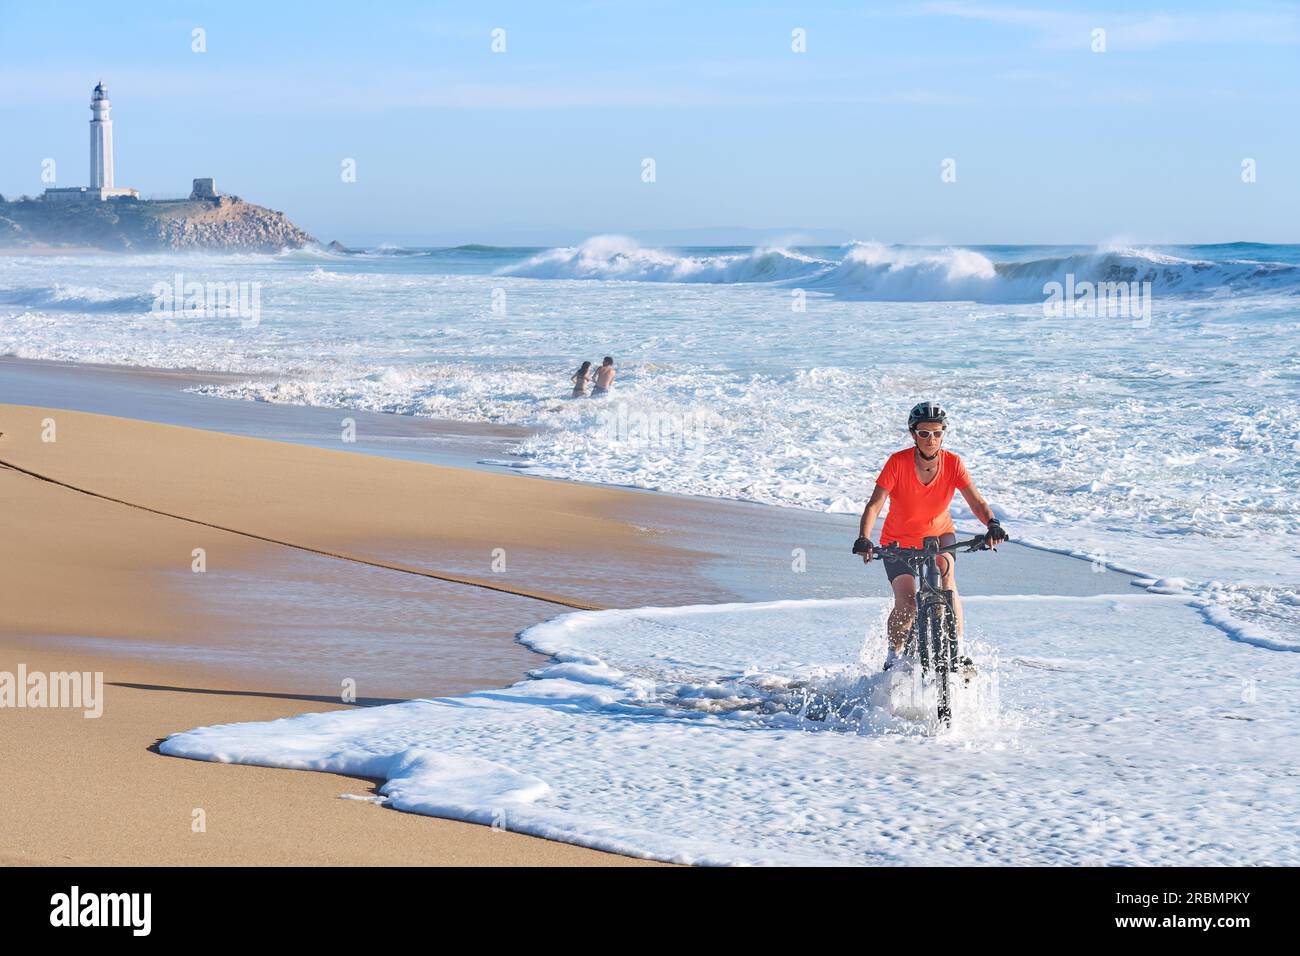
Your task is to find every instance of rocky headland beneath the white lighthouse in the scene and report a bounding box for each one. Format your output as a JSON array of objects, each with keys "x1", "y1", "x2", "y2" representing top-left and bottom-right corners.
[{"x1": 0, "y1": 196, "x2": 316, "y2": 252}]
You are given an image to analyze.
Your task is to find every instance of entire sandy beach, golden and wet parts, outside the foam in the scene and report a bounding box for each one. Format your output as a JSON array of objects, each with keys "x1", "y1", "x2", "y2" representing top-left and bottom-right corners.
[{"x1": 0, "y1": 364, "x2": 1131, "y2": 865}]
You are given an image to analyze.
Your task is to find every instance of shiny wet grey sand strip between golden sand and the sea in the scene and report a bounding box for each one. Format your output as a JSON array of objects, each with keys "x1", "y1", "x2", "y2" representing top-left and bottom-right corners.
[{"x1": 0, "y1": 355, "x2": 1144, "y2": 601}]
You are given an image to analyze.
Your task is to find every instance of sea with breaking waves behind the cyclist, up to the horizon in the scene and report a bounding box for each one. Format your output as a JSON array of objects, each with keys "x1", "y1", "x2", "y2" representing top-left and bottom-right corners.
[{"x1": 0, "y1": 237, "x2": 1300, "y2": 648}]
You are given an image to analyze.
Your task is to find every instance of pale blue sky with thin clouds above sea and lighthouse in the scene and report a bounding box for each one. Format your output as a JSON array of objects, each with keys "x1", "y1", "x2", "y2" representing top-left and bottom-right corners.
[{"x1": 0, "y1": 0, "x2": 1300, "y2": 245}]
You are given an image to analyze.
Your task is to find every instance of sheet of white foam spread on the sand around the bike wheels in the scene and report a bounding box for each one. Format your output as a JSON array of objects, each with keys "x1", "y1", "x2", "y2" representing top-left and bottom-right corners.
[{"x1": 160, "y1": 594, "x2": 1300, "y2": 865}]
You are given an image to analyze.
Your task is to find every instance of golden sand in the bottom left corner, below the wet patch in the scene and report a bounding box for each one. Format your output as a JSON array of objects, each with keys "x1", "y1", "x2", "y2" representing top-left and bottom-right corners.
[{"x1": 0, "y1": 636, "x2": 658, "y2": 866}]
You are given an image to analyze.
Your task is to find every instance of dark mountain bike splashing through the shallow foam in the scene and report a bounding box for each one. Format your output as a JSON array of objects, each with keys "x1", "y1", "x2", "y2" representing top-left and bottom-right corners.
[{"x1": 853, "y1": 535, "x2": 1010, "y2": 727}]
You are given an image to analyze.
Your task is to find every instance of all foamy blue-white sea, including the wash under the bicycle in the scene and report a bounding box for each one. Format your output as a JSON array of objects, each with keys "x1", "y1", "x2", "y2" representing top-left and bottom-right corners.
[{"x1": 12, "y1": 237, "x2": 1300, "y2": 865}]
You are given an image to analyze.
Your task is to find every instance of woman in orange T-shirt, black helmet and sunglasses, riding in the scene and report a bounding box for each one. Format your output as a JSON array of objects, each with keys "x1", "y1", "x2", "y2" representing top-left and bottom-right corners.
[{"x1": 854, "y1": 402, "x2": 1006, "y2": 670}]
